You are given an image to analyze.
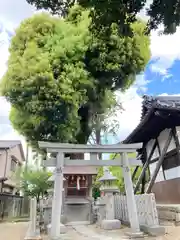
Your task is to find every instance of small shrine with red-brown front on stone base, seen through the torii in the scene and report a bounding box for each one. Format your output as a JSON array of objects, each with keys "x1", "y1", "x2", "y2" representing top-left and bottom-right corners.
[{"x1": 45, "y1": 163, "x2": 98, "y2": 225}]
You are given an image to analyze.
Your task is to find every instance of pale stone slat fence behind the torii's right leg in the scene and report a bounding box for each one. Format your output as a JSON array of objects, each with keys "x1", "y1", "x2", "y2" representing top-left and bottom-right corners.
[{"x1": 114, "y1": 193, "x2": 159, "y2": 226}]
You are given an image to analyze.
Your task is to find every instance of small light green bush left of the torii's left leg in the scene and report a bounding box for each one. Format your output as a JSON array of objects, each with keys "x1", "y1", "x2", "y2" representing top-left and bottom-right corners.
[{"x1": 14, "y1": 166, "x2": 52, "y2": 201}]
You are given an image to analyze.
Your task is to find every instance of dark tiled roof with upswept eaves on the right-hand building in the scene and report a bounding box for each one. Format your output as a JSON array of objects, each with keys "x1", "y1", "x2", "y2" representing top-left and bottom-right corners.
[{"x1": 123, "y1": 95, "x2": 180, "y2": 143}]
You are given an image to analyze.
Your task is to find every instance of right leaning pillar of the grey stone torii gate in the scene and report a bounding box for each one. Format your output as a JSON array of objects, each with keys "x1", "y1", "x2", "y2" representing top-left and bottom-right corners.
[{"x1": 122, "y1": 153, "x2": 140, "y2": 233}]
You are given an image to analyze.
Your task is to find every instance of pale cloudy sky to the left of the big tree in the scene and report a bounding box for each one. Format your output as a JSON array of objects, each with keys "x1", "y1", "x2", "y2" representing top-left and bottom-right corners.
[{"x1": 0, "y1": 0, "x2": 35, "y2": 150}]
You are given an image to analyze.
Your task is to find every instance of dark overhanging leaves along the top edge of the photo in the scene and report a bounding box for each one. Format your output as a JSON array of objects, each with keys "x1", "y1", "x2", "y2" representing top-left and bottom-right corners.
[{"x1": 26, "y1": 0, "x2": 180, "y2": 34}]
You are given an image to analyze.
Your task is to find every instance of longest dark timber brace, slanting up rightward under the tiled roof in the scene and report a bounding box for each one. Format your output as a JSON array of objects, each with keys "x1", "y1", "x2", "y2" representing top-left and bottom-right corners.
[{"x1": 146, "y1": 130, "x2": 173, "y2": 193}]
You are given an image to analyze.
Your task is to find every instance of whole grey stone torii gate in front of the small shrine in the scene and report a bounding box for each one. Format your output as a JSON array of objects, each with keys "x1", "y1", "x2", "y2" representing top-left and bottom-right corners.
[{"x1": 39, "y1": 142, "x2": 142, "y2": 239}]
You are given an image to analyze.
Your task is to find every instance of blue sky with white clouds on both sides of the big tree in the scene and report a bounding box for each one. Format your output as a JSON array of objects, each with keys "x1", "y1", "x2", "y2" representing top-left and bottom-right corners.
[{"x1": 0, "y1": 0, "x2": 180, "y2": 148}]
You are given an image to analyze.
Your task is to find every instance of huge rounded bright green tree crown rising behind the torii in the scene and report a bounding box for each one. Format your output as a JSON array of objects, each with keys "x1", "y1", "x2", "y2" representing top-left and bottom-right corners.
[{"x1": 1, "y1": 6, "x2": 150, "y2": 149}]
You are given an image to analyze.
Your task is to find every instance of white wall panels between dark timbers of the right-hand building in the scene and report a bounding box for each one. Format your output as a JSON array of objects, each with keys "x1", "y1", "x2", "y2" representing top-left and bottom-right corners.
[{"x1": 146, "y1": 127, "x2": 180, "y2": 182}]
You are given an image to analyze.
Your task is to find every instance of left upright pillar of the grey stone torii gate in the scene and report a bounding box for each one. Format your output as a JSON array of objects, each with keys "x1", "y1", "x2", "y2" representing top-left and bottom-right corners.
[{"x1": 51, "y1": 152, "x2": 64, "y2": 239}]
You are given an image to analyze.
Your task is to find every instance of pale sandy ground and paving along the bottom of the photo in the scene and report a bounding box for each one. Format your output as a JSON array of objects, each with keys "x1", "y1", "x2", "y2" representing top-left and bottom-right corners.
[{"x1": 0, "y1": 223, "x2": 180, "y2": 240}]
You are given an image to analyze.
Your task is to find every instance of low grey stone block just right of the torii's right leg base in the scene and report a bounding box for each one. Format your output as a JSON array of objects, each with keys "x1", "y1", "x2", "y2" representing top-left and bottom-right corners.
[{"x1": 141, "y1": 225, "x2": 166, "y2": 237}]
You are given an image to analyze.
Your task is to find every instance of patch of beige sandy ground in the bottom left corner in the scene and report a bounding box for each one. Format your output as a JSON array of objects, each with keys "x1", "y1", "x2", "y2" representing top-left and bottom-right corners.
[{"x1": 0, "y1": 223, "x2": 28, "y2": 240}]
